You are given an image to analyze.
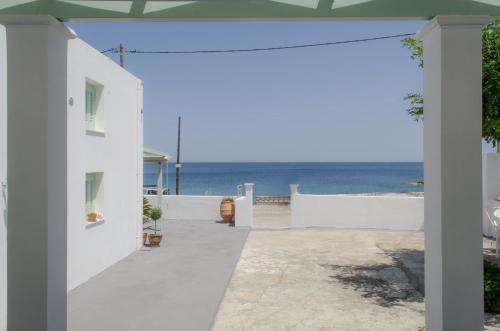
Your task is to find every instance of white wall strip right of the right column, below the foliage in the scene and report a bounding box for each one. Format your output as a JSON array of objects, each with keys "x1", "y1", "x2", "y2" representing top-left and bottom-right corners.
[{"x1": 483, "y1": 153, "x2": 500, "y2": 237}]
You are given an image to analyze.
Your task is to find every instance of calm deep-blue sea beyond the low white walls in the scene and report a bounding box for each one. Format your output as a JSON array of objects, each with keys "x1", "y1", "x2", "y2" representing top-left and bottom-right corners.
[{"x1": 144, "y1": 162, "x2": 423, "y2": 195}]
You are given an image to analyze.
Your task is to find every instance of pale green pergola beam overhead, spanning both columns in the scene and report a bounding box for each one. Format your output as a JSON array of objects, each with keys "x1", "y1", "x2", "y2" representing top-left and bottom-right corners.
[{"x1": 0, "y1": 0, "x2": 500, "y2": 21}]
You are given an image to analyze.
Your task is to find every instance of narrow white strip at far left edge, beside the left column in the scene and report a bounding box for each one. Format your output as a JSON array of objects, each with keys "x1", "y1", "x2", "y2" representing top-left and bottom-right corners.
[{"x1": 0, "y1": 25, "x2": 7, "y2": 331}]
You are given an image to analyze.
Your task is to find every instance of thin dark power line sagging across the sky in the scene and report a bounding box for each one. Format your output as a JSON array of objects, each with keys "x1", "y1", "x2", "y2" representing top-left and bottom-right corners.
[{"x1": 98, "y1": 33, "x2": 414, "y2": 54}]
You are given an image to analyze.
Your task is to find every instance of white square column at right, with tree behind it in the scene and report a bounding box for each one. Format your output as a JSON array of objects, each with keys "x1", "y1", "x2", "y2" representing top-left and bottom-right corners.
[{"x1": 418, "y1": 16, "x2": 488, "y2": 331}]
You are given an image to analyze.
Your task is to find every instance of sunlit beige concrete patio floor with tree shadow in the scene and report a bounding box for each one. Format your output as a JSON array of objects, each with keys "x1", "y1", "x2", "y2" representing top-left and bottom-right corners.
[{"x1": 213, "y1": 229, "x2": 500, "y2": 331}]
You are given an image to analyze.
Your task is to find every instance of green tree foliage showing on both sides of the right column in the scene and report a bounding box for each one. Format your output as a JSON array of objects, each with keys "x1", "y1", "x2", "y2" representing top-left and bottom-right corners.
[{"x1": 402, "y1": 21, "x2": 500, "y2": 146}]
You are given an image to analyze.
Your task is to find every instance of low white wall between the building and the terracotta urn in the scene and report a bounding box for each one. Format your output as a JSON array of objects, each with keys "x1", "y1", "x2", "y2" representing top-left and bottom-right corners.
[{"x1": 146, "y1": 195, "x2": 228, "y2": 221}]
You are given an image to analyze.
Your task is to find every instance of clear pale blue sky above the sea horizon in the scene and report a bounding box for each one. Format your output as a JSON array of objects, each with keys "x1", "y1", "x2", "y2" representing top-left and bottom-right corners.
[{"x1": 69, "y1": 22, "x2": 434, "y2": 162}]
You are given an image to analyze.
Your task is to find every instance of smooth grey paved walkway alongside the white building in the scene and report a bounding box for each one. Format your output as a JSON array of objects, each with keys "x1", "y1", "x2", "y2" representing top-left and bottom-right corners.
[{"x1": 68, "y1": 221, "x2": 248, "y2": 331}]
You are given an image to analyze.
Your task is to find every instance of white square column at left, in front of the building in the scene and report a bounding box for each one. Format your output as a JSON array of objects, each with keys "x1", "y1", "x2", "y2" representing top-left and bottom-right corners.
[{"x1": 0, "y1": 15, "x2": 74, "y2": 331}]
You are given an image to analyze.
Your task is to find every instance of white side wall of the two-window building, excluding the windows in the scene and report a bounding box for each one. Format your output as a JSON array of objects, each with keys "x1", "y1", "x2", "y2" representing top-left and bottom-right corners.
[{"x1": 68, "y1": 39, "x2": 142, "y2": 289}]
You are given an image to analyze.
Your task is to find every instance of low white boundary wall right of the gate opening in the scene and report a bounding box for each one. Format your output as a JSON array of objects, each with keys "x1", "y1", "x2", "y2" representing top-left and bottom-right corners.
[{"x1": 290, "y1": 185, "x2": 424, "y2": 231}]
